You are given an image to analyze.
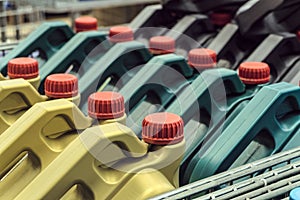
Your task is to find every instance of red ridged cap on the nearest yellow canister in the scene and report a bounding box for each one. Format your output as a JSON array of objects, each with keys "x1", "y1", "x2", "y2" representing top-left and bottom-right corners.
[{"x1": 142, "y1": 112, "x2": 184, "y2": 145}]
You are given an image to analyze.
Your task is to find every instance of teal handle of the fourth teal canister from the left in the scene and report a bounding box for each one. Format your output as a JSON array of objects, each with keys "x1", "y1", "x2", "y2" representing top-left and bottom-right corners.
[{"x1": 120, "y1": 54, "x2": 193, "y2": 109}]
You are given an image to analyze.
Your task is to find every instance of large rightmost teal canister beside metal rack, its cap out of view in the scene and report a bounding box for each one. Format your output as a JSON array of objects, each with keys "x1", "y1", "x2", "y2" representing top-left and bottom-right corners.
[{"x1": 189, "y1": 83, "x2": 300, "y2": 182}]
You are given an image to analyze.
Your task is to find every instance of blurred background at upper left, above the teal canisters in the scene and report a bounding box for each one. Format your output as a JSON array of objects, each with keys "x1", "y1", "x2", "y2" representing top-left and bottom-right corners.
[{"x1": 0, "y1": 0, "x2": 160, "y2": 43}]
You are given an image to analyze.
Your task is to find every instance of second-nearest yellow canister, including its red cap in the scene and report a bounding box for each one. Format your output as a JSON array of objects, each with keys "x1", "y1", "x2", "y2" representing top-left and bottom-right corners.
[{"x1": 0, "y1": 92, "x2": 126, "y2": 199}]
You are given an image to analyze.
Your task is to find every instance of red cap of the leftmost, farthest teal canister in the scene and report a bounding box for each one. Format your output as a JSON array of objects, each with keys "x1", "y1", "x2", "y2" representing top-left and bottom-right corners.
[{"x1": 75, "y1": 16, "x2": 98, "y2": 33}]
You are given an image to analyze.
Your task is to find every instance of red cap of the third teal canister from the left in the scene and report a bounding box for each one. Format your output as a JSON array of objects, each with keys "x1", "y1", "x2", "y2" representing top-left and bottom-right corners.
[{"x1": 149, "y1": 36, "x2": 175, "y2": 54}]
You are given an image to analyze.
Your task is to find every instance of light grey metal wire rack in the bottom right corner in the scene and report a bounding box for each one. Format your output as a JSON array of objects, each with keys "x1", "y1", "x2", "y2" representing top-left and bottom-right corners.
[{"x1": 151, "y1": 147, "x2": 300, "y2": 200}]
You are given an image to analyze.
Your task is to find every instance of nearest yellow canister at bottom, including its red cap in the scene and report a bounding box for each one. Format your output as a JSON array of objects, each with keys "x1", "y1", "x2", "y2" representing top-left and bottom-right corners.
[{"x1": 16, "y1": 113, "x2": 185, "y2": 200}]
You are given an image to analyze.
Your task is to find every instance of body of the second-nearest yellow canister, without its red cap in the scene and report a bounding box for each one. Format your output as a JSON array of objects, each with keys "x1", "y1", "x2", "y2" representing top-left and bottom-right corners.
[{"x1": 0, "y1": 99, "x2": 92, "y2": 197}]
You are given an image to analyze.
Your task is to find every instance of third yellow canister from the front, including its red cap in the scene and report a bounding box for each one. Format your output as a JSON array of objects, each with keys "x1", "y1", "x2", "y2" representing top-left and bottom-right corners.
[{"x1": 0, "y1": 74, "x2": 80, "y2": 134}]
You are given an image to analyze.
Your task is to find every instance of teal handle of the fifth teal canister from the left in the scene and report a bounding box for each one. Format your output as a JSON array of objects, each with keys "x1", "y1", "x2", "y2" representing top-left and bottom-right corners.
[{"x1": 167, "y1": 69, "x2": 245, "y2": 122}]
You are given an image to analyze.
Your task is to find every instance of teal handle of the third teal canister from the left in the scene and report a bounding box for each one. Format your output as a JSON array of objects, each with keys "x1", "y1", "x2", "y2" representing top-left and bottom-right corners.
[{"x1": 79, "y1": 41, "x2": 152, "y2": 108}]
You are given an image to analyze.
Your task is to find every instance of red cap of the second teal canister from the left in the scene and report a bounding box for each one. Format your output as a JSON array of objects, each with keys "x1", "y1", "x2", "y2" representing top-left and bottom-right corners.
[{"x1": 109, "y1": 26, "x2": 133, "y2": 43}]
